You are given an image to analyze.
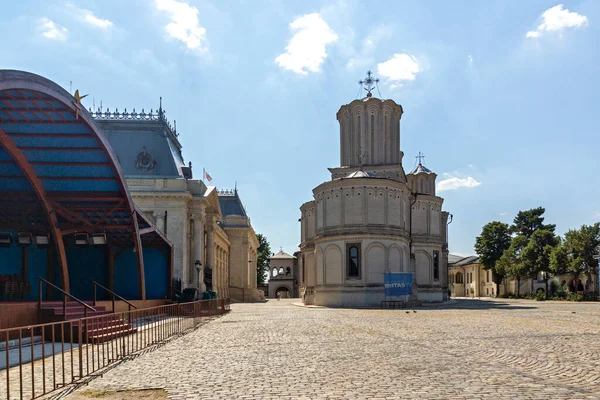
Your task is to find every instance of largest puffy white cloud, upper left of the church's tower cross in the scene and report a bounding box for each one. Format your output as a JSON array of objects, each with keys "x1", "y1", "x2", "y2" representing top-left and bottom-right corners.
[{"x1": 275, "y1": 13, "x2": 338, "y2": 75}]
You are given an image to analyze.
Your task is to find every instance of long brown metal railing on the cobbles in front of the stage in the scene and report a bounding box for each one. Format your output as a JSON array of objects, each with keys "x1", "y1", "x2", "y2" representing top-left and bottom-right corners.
[{"x1": 0, "y1": 299, "x2": 230, "y2": 400}]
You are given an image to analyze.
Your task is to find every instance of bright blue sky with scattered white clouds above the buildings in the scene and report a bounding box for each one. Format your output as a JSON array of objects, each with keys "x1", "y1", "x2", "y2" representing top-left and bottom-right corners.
[{"x1": 0, "y1": 0, "x2": 600, "y2": 255}]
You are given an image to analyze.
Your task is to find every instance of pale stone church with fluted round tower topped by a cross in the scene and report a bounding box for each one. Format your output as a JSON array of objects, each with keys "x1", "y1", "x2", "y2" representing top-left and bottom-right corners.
[{"x1": 300, "y1": 72, "x2": 449, "y2": 307}]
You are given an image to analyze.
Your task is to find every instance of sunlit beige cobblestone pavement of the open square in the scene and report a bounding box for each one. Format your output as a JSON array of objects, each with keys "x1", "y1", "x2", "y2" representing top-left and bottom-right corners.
[{"x1": 67, "y1": 299, "x2": 600, "y2": 400}]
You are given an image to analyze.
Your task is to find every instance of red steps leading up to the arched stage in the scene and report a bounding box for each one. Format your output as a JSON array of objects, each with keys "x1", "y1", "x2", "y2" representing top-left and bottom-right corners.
[{"x1": 41, "y1": 301, "x2": 137, "y2": 343}]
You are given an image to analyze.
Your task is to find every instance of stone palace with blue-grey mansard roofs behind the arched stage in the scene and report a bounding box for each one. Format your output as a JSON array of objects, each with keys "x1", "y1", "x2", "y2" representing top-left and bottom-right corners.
[{"x1": 90, "y1": 106, "x2": 260, "y2": 301}]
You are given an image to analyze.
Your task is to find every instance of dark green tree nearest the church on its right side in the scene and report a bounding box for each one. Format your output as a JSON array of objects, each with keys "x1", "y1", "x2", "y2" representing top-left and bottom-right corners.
[{"x1": 475, "y1": 221, "x2": 511, "y2": 295}]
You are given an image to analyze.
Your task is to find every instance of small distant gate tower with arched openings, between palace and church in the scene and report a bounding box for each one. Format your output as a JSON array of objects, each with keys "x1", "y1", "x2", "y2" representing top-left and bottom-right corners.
[{"x1": 269, "y1": 249, "x2": 298, "y2": 299}]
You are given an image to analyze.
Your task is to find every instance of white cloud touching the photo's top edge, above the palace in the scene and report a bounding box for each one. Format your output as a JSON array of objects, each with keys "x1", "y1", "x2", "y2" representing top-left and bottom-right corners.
[{"x1": 154, "y1": 0, "x2": 207, "y2": 52}]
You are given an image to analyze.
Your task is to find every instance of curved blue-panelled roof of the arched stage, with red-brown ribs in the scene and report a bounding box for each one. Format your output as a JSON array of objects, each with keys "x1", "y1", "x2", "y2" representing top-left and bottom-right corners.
[{"x1": 0, "y1": 70, "x2": 171, "y2": 247}]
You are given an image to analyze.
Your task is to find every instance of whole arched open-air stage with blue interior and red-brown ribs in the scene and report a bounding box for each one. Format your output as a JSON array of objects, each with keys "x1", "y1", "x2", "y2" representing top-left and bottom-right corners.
[{"x1": 0, "y1": 70, "x2": 172, "y2": 300}]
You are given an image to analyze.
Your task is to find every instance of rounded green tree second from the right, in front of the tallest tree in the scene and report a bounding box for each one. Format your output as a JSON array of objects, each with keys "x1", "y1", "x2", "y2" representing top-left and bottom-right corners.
[{"x1": 523, "y1": 229, "x2": 558, "y2": 298}]
